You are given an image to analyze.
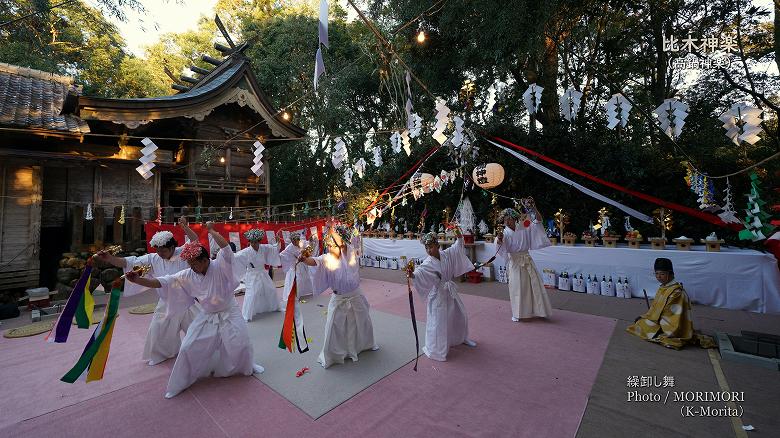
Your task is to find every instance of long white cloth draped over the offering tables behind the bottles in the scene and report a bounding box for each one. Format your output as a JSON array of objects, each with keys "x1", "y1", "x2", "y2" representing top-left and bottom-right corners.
[{"x1": 363, "y1": 238, "x2": 780, "y2": 314}]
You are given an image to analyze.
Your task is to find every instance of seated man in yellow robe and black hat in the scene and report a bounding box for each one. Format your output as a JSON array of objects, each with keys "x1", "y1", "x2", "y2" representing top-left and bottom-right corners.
[{"x1": 626, "y1": 258, "x2": 699, "y2": 349}]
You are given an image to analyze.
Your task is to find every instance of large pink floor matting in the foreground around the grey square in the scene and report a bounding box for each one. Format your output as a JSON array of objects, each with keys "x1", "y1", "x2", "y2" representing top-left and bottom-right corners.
[{"x1": 0, "y1": 280, "x2": 615, "y2": 438}]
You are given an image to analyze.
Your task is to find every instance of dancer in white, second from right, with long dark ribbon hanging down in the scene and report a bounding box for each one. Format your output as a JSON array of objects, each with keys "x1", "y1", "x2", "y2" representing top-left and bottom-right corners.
[{"x1": 410, "y1": 229, "x2": 477, "y2": 362}]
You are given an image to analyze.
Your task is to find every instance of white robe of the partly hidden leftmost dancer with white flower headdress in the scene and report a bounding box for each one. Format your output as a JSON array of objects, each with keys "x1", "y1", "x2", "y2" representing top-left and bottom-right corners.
[{"x1": 123, "y1": 247, "x2": 200, "y2": 364}]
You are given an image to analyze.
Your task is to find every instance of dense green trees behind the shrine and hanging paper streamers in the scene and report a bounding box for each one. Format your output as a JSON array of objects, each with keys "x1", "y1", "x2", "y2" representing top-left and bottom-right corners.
[{"x1": 0, "y1": 0, "x2": 780, "y2": 243}]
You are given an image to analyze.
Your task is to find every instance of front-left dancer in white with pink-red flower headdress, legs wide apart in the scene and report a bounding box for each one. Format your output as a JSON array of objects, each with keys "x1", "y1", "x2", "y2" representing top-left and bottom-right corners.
[{"x1": 126, "y1": 222, "x2": 264, "y2": 398}]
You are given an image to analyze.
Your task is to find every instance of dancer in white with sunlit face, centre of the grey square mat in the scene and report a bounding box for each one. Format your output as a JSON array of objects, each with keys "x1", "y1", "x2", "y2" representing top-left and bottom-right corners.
[{"x1": 301, "y1": 225, "x2": 379, "y2": 368}]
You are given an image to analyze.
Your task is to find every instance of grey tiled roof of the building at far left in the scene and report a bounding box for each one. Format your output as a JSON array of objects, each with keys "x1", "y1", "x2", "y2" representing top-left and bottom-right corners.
[{"x1": 0, "y1": 63, "x2": 89, "y2": 134}]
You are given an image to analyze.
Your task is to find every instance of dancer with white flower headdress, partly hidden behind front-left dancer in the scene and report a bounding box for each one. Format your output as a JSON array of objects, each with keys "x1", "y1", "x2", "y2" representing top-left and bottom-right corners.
[{"x1": 98, "y1": 218, "x2": 200, "y2": 365}]
